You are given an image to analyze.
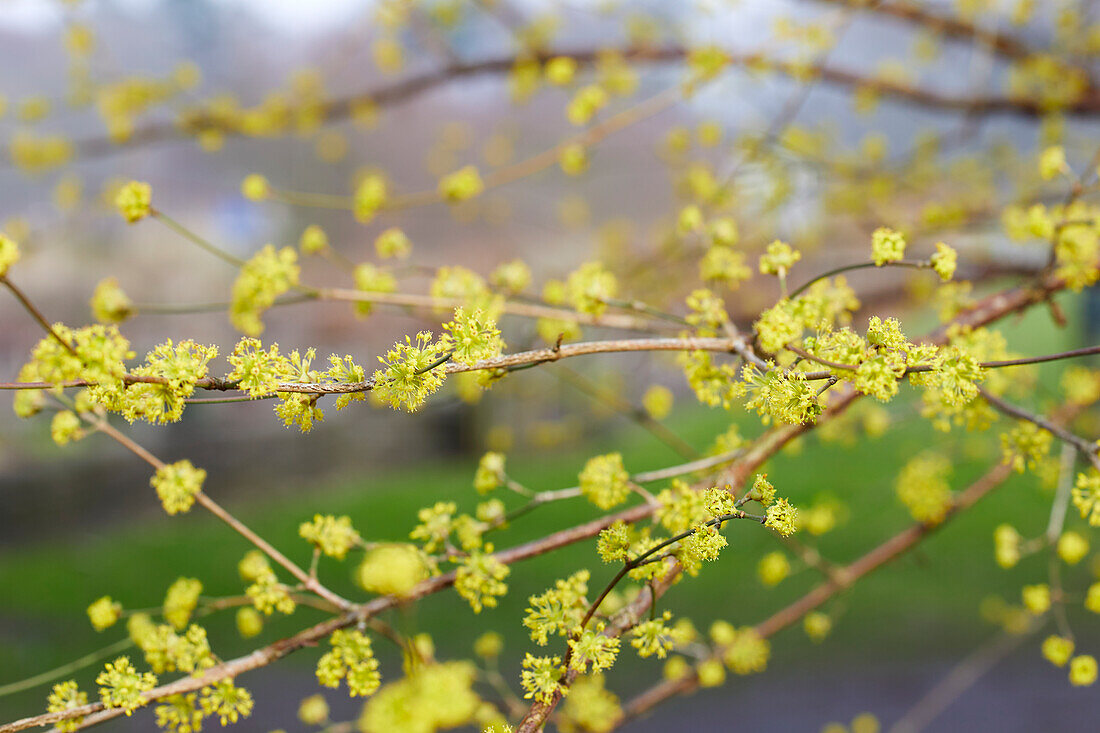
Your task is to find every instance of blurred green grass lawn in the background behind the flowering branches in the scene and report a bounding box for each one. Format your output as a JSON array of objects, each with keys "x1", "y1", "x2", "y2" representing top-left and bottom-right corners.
[{"x1": 0, "y1": 286, "x2": 1087, "y2": 719}]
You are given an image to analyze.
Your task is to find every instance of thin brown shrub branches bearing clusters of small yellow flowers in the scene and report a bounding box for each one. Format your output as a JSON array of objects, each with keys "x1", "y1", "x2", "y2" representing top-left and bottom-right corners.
[{"x1": 0, "y1": 1, "x2": 1100, "y2": 733}]
